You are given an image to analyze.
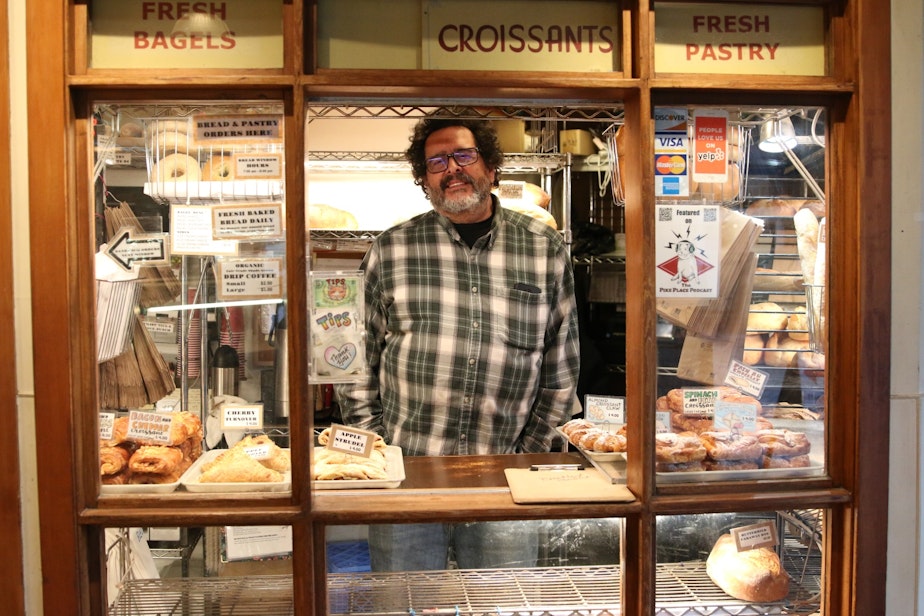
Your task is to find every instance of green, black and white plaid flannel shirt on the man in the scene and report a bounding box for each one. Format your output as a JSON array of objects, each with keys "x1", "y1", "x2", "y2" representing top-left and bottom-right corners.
[{"x1": 337, "y1": 200, "x2": 579, "y2": 455}]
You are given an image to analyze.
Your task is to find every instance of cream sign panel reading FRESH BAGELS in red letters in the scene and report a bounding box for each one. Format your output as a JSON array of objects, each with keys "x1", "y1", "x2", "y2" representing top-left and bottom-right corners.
[{"x1": 90, "y1": 0, "x2": 283, "y2": 69}]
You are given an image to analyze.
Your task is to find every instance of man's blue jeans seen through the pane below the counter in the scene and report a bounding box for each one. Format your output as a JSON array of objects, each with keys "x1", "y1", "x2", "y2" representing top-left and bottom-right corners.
[{"x1": 369, "y1": 520, "x2": 539, "y2": 571}]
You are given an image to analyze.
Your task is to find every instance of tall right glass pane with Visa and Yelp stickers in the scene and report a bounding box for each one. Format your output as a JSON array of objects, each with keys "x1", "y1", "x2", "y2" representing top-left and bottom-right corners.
[{"x1": 655, "y1": 108, "x2": 828, "y2": 484}]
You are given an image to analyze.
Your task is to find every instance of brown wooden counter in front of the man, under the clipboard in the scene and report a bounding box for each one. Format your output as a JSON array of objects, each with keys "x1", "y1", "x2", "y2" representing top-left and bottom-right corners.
[{"x1": 312, "y1": 452, "x2": 641, "y2": 524}]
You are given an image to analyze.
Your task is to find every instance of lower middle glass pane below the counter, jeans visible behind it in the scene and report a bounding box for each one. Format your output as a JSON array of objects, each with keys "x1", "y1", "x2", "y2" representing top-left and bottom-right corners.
[{"x1": 327, "y1": 518, "x2": 622, "y2": 614}]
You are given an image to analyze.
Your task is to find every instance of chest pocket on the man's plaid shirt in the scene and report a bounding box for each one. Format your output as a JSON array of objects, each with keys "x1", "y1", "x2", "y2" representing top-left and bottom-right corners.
[{"x1": 487, "y1": 284, "x2": 549, "y2": 352}]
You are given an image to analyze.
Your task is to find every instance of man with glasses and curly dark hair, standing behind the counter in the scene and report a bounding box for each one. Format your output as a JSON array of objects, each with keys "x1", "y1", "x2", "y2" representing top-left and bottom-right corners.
[{"x1": 338, "y1": 118, "x2": 579, "y2": 571}]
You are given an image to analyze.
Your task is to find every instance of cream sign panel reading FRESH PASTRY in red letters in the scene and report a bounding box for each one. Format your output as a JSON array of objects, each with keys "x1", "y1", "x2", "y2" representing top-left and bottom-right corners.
[{"x1": 655, "y1": 2, "x2": 826, "y2": 76}]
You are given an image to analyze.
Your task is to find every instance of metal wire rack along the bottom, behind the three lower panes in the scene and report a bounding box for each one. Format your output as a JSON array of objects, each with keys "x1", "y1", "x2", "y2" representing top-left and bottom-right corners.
[{"x1": 110, "y1": 548, "x2": 820, "y2": 616}]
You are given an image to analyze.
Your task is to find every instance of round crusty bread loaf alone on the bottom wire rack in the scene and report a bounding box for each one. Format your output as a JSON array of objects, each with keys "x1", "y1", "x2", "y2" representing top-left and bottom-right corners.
[{"x1": 706, "y1": 534, "x2": 789, "y2": 603}]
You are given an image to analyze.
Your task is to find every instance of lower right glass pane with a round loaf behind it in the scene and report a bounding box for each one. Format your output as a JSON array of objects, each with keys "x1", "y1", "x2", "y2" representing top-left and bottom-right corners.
[{"x1": 655, "y1": 509, "x2": 824, "y2": 616}]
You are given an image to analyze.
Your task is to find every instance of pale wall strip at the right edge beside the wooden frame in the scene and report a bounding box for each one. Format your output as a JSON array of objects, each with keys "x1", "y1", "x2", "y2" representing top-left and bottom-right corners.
[{"x1": 886, "y1": 0, "x2": 924, "y2": 616}]
